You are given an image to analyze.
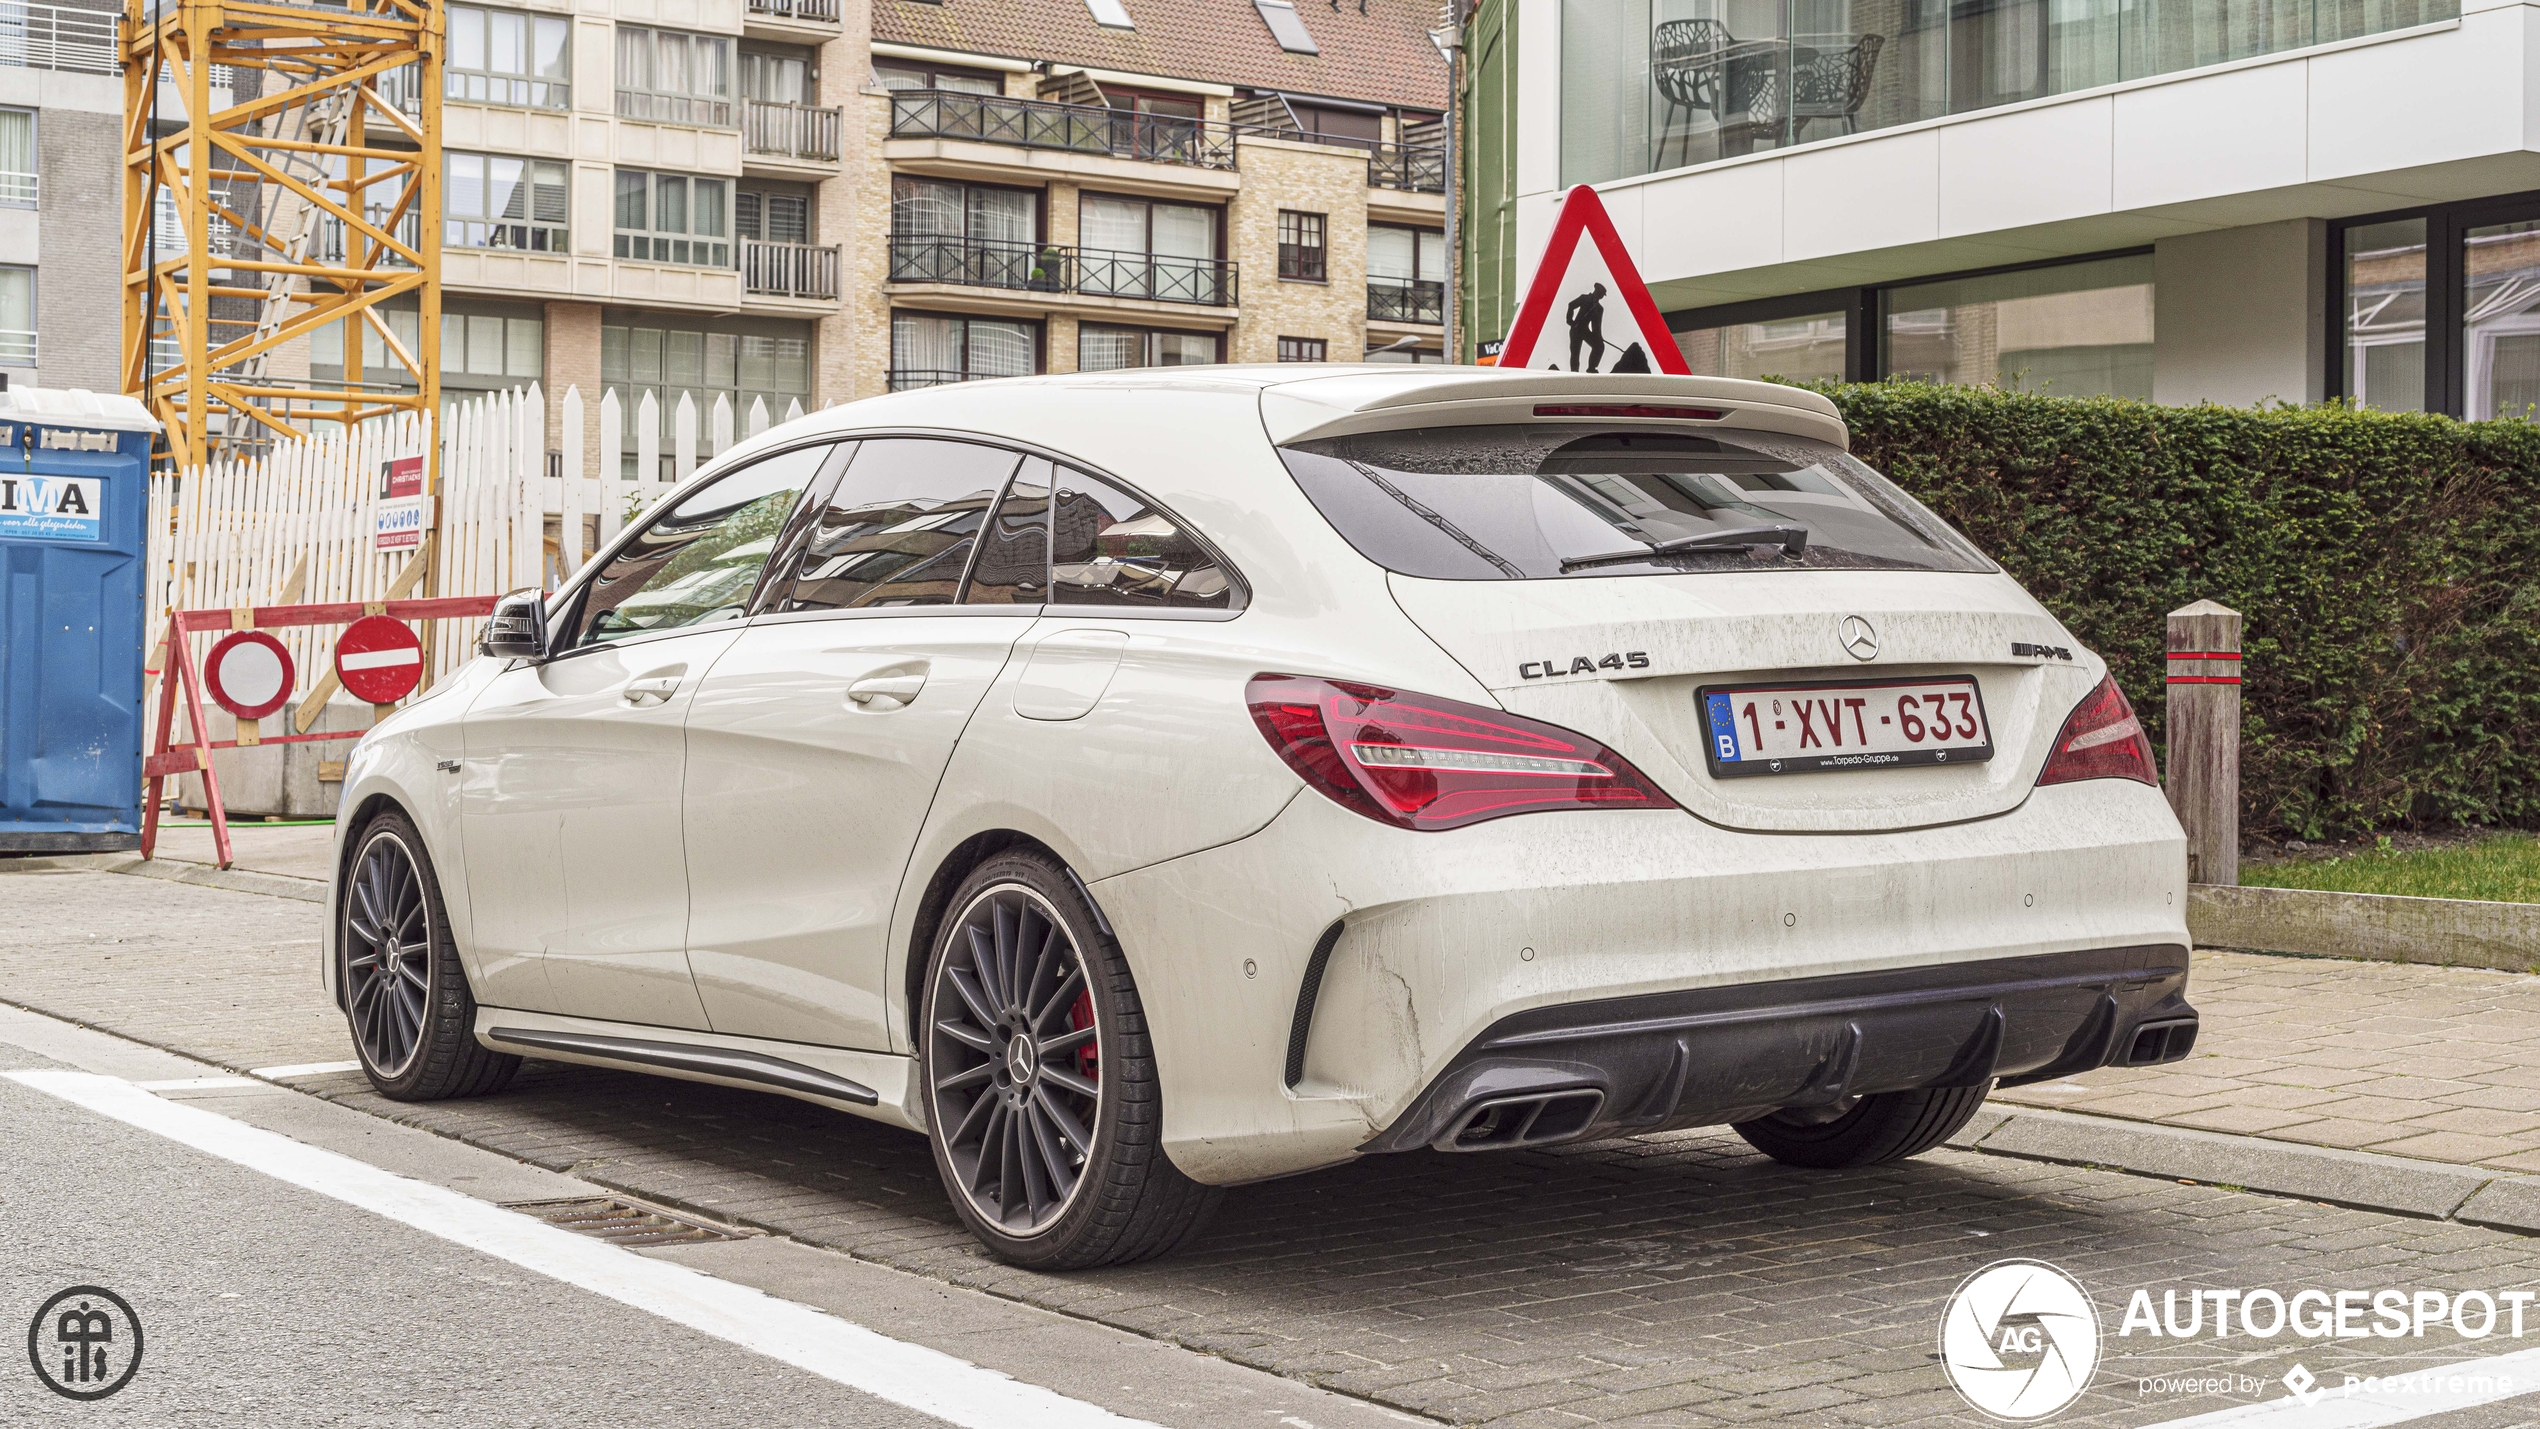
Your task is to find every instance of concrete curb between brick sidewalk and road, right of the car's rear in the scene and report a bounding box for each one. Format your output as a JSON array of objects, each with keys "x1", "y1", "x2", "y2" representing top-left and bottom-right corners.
[{"x1": 1948, "y1": 1107, "x2": 2540, "y2": 1234}]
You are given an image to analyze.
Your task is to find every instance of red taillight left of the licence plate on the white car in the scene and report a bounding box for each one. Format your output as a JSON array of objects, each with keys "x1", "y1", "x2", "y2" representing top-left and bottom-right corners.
[{"x1": 1245, "y1": 675, "x2": 1676, "y2": 830}]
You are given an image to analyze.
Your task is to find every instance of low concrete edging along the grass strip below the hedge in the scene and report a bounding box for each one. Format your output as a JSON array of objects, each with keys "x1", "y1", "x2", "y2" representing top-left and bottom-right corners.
[{"x1": 2187, "y1": 883, "x2": 2540, "y2": 972}]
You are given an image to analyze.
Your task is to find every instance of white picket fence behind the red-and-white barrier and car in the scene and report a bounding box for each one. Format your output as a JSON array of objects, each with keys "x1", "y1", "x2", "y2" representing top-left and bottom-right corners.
[{"x1": 150, "y1": 383, "x2": 803, "y2": 701}]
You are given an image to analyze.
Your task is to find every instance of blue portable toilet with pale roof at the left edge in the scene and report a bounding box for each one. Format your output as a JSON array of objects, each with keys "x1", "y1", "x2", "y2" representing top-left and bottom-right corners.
[{"x1": 0, "y1": 388, "x2": 157, "y2": 853}]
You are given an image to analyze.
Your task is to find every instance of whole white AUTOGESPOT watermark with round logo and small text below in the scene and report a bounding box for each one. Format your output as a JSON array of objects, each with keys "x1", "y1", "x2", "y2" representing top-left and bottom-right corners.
[{"x1": 1941, "y1": 1259, "x2": 2540, "y2": 1424}]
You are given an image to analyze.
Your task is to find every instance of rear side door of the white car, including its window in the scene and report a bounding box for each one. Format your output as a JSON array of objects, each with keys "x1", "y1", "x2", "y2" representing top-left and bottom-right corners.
[{"x1": 686, "y1": 437, "x2": 1049, "y2": 1051}]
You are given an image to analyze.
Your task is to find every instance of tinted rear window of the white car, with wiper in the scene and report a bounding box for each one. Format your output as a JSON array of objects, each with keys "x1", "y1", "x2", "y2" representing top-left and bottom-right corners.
[{"x1": 1280, "y1": 421, "x2": 1994, "y2": 581}]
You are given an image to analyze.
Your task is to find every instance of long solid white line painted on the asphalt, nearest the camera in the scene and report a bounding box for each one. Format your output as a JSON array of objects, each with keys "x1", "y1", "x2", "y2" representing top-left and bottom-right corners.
[{"x1": 0, "y1": 1069, "x2": 1158, "y2": 1429}]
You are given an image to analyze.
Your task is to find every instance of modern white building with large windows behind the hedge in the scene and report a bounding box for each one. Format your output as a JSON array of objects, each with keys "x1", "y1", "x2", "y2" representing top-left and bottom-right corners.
[{"x1": 1468, "y1": 0, "x2": 2540, "y2": 419}]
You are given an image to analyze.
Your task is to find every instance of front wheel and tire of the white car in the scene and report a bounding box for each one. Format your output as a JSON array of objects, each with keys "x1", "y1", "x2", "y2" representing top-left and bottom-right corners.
[{"x1": 335, "y1": 812, "x2": 521, "y2": 1102}]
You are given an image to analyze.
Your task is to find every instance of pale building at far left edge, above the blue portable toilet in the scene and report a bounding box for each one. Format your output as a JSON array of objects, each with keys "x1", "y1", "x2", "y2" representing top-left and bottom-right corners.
[{"x1": 0, "y1": 0, "x2": 124, "y2": 391}]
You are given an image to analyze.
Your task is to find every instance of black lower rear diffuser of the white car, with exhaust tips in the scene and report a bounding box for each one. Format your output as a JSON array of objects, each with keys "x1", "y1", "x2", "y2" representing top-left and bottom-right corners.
[{"x1": 1359, "y1": 944, "x2": 2197, "y2": 1152}]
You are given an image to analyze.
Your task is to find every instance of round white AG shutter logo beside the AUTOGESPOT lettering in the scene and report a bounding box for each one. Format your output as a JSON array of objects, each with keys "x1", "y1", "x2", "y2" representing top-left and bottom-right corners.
[{"x1": 1941, "y1": 1261, "x2": 2098, "y2": 1421}]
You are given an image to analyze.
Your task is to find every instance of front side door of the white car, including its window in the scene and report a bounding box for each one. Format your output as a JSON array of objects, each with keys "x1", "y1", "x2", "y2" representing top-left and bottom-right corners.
[{"x1": 460, "y1": 444, "x2": 831, "y2": 1028}]
